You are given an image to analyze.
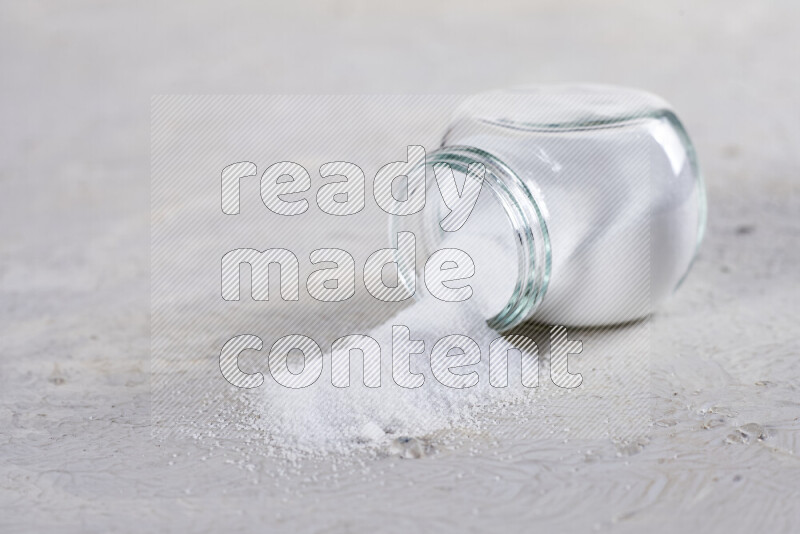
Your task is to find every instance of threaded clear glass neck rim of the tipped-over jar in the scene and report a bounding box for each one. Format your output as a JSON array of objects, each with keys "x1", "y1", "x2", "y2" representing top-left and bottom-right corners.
[{"x1": 390, "y1": 145, "x2": 551, "y2": 331}]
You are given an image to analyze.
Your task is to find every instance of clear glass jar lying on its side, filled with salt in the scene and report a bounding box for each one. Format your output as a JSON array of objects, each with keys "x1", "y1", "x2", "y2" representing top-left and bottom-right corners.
[{"x1": 391, "y1": 85, "x2": 706, "y2": 330}]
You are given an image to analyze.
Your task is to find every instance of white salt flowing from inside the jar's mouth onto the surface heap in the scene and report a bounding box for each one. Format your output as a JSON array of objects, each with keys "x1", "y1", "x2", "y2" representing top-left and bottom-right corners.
[{"x1": 247, "y1": 179, "x2": 537, "y2": 456}]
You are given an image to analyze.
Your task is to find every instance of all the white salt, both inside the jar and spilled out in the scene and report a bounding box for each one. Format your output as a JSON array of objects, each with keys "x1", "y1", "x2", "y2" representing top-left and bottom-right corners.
[{"x1": 250, "y1": 89, "x2": 702, "y2": 455}]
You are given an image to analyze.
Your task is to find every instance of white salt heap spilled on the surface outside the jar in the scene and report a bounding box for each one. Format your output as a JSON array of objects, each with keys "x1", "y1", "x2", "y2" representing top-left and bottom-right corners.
[{"x1": 250, "y1": 260, "x2": 532, "y2": 451}]
